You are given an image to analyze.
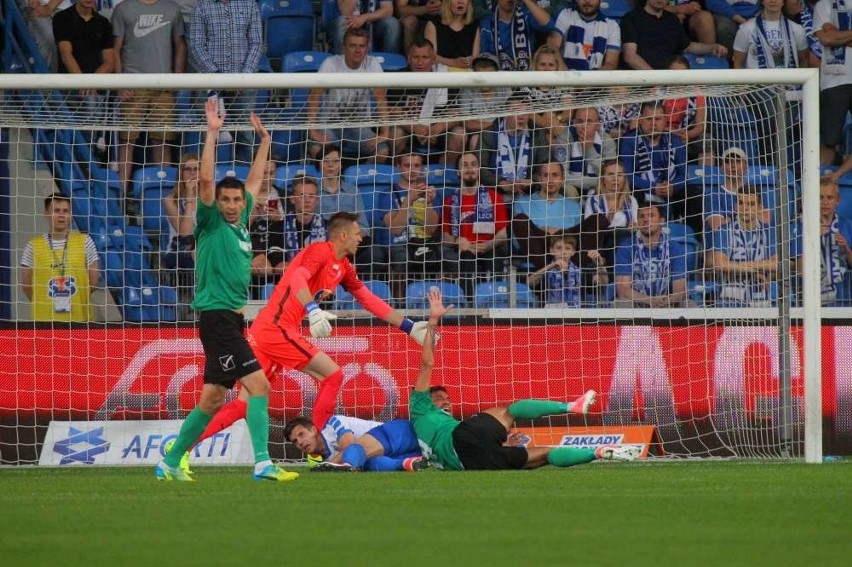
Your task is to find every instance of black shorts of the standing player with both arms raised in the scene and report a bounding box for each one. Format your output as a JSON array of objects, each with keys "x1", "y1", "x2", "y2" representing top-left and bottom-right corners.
[{"x1": 198, "y1": 309, "x2": 261, "y2": 388}]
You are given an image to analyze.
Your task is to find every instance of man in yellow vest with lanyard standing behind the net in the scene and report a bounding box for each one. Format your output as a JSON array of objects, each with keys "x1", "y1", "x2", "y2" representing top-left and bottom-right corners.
[{"x1": 21, "y1": 193, "x2": 100, "y2": 322}]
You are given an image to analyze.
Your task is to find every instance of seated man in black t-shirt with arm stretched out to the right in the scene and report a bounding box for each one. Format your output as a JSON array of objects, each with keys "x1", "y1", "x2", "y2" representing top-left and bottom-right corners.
[{"x1": 621, "y1": 0, "x2": 733, "y2": 71}]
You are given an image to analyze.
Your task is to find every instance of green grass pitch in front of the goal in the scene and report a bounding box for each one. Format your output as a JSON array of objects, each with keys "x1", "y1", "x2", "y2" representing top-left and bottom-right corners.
[{"x1": 0, "y1": 462, "x2": 852, "y2": 567}]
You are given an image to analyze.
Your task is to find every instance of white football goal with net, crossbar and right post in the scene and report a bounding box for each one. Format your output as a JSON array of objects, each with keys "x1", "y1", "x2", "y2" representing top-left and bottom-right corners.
[{"x1": 0, "y1": 67, "x2": 828, "y2": 465}]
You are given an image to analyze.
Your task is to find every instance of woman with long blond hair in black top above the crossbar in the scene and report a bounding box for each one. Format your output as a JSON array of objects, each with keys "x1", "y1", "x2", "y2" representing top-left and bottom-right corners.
[{"x1": 423, "y1": 0, "x2": 479, "y2": 71}]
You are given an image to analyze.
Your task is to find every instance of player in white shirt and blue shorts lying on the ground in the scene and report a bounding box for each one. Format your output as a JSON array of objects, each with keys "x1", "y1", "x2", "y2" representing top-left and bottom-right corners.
[{"x1": 284, "y1": 415, "x2": 426, "y2": 472}]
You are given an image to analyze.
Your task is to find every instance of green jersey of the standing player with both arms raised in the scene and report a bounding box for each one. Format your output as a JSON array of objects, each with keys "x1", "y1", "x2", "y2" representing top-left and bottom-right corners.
[{"x1": 192, "y1": 192, "x2": 254, "y2": 311}]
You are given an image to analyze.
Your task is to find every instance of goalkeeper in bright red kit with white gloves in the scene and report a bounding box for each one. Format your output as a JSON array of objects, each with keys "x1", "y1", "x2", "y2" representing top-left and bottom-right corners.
[{"x1": 181, "y1": 212, "x2": 426, "y2": 468}]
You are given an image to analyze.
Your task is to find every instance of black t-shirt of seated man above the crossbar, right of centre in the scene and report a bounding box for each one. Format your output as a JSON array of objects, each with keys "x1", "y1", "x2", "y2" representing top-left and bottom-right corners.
[{"x1": 621, "y1": 8, "x2": 690, "y2": 69}]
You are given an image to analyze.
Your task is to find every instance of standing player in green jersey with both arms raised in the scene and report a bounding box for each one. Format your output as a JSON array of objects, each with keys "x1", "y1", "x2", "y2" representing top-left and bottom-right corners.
[{"x1": 155, "y1": 98, "x2": 299, "y2": 481}]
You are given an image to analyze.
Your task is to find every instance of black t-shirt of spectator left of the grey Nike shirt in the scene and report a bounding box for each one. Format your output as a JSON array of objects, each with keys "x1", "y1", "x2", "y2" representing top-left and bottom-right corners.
[{"x1": 53, "y1": 6, "x2": 113, "y2": 73}]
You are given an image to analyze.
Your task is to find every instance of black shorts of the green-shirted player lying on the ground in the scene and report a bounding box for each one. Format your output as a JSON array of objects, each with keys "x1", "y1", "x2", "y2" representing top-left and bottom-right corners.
[{"x1": 453, "y1": 413, "x2": 527, "y2": 471}]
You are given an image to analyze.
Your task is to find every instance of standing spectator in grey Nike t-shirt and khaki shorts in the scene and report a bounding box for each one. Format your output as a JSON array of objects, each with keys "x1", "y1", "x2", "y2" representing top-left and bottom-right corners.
[{"x1": 112, "y1": 0, "x2": 186, "y2": 204}]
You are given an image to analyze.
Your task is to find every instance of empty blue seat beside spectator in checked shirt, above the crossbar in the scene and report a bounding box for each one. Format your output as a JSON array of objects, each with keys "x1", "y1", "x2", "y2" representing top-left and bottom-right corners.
[{"x1": 260, "y1": 0, "x2": 314, "y2": 67}]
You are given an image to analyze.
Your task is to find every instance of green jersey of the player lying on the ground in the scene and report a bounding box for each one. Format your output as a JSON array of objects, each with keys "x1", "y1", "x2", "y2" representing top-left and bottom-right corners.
[{"x1": 408, "y1": 391, "x2": 464, "y2": 471}]
